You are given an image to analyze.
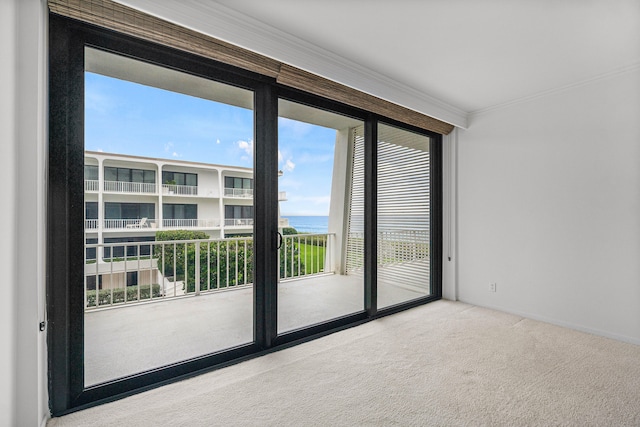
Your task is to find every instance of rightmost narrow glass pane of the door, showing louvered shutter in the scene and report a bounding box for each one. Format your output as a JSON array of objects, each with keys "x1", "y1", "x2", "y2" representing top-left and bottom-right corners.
[{"x1": 377, "y1": 124, "x2": 431, "y2": 308}]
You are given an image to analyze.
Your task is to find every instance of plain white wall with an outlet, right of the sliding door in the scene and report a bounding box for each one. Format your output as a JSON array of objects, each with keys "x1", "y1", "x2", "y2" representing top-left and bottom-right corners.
[{"x1": 457, "y1": 68, "x2": 640, "y2": 343}]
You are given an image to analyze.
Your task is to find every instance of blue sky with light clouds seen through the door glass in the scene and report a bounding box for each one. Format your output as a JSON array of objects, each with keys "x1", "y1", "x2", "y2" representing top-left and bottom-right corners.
[{"x1": 85, "y1": 72, "x2": 336, "y2": 216}]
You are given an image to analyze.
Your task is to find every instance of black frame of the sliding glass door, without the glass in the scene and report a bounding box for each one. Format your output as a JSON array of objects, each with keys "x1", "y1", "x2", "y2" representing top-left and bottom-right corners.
[{"x1": 47, "y1": 14, "x2": 442, "y2": 416}]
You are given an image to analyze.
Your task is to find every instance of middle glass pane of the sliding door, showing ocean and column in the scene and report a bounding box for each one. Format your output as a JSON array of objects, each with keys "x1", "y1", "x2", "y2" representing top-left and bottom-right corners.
[{"x1": 278, "y1": 99, "x2": 364, "y2": 333}]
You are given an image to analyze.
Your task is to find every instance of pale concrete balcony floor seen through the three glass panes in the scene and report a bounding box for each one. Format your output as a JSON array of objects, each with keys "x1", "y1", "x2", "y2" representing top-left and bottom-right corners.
[{"x1": 84, "y1": 275, "x2": 428, "y2": 386}]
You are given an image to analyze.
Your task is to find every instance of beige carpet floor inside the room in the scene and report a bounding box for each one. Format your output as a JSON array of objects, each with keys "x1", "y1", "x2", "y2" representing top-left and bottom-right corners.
[{"x1": 47, "y1": 301, "x2": 640, "y2": 427}]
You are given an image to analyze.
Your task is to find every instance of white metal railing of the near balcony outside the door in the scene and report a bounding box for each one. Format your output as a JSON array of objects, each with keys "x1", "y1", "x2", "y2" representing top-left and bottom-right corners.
[{"x1": 84, "y1": 234, "x2": 335, "y2": 310}]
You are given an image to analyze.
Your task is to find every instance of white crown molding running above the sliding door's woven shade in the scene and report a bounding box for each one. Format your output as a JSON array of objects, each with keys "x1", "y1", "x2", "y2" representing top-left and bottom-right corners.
[{"x1": 115, "y1": 0, "x2": 467, "y2": 128}]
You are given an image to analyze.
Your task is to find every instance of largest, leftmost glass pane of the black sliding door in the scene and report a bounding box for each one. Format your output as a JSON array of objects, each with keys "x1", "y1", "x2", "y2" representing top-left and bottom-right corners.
[{"x1": 84, "y1": 48, "x2": 254, "y2": 386}]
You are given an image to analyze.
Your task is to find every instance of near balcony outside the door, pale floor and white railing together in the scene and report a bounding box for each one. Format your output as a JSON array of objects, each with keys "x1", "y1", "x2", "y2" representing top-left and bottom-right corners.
[{"x1": 84, "y1": 234, "x2": 429, "y2": 386}]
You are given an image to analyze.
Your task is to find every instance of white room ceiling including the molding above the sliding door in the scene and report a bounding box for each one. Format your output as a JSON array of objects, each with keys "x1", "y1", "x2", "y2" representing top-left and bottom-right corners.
[{"x1": 118, "y1": 0, "x2": 640, "y2": 127}]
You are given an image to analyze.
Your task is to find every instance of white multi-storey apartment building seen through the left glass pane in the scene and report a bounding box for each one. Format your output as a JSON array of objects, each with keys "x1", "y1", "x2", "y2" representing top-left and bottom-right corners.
[{"x1": 84, "y1": 151, "x2": 288, "y2": 288}]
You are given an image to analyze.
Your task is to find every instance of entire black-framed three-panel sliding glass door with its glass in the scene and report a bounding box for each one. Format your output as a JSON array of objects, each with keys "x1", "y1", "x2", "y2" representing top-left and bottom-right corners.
[{"x1": 47, "y1": 14, "x2": 441, "y2": 415}]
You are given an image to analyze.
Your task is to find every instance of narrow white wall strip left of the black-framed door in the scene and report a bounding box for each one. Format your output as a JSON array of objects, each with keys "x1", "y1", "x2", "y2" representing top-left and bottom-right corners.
[{"x1": 0, "y1": 0, "x2": 48, "y2": 426}]
